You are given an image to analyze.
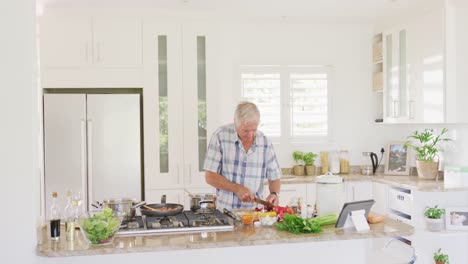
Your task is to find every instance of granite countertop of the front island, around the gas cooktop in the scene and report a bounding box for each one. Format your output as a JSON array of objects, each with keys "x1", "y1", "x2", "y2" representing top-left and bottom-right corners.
[{"x1": 36, "y1": 218, "x2": 414, "y2": 257}]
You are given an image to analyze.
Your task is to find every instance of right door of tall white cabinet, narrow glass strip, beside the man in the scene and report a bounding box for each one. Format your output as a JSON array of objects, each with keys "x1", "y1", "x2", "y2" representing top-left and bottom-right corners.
[{"x1": 182, "y1": 24, "x2": 217, "y2": 187}]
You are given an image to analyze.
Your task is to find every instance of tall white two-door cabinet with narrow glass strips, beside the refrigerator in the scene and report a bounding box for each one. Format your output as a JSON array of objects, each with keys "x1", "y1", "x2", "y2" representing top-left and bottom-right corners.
[{"x1": 143, "y1": 22, "x2": 216, "y2": 189}]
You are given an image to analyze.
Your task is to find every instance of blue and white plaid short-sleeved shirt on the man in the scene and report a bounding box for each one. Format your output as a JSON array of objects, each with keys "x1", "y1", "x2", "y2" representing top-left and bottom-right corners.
[{"x1": 203, "y1": 124, "x2": 281, "y2": 209}]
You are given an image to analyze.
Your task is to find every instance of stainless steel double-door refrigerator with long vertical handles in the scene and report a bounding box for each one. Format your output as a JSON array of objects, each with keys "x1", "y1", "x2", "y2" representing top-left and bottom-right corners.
[{"x1": 44, "y1": 93, "x2": 143, "y2": 218}]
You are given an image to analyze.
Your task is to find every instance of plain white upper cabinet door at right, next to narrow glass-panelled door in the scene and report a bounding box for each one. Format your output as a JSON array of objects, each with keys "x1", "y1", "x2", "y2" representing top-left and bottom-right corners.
[{"x1": 407, "y1": 9, "x2": 445, "y2": 123}]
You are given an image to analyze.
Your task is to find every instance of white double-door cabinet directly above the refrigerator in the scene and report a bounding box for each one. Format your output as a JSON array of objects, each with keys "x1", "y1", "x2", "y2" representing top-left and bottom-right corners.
[{"x1": 39, "y1": 13, "x2": 143, "y2": 88}]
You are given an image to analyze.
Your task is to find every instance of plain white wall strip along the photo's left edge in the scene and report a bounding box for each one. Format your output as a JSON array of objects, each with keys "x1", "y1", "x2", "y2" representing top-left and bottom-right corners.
[{"x1": 0, "y1": 0, "x2": 39, "y2": 263}]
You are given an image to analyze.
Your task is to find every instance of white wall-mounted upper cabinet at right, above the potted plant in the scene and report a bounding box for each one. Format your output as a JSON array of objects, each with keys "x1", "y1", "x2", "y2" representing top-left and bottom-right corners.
[{"x1": 373, "y1": 1, "x2": 468, "y2": 123}]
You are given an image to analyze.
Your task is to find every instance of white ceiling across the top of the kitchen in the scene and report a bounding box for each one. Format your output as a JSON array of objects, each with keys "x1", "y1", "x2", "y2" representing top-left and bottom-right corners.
[{"x1": 37, "y1": 0, "x2": 443, "y2": 22}]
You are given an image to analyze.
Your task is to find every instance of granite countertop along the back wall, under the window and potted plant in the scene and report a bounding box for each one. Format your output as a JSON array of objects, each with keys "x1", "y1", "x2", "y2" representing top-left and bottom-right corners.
[{"x1": 281, "y1": 174, "x2": 468, "y2": 192}]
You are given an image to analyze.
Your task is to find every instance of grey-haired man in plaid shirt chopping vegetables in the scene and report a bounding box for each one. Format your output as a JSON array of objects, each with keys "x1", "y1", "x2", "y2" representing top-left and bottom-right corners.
[{"x1": 204, "y1": 102, "x2": 281, "y2": 209}]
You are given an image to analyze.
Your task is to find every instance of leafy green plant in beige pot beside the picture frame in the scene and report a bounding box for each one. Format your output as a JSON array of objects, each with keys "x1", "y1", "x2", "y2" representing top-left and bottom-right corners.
[{"x1": 405, "y1": 128, "x2": 451, "y2": 180}]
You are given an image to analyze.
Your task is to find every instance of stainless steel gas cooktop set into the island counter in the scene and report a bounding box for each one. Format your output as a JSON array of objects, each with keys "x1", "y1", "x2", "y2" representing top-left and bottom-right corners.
[{"x1": 117, "y1": 210, "x2": 234, "y2": 236}]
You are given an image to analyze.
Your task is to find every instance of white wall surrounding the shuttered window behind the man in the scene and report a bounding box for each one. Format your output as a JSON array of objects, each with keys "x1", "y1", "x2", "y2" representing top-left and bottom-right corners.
[{"x1": 210, "y1": 23, "x2": 412, "y2": 167}]
